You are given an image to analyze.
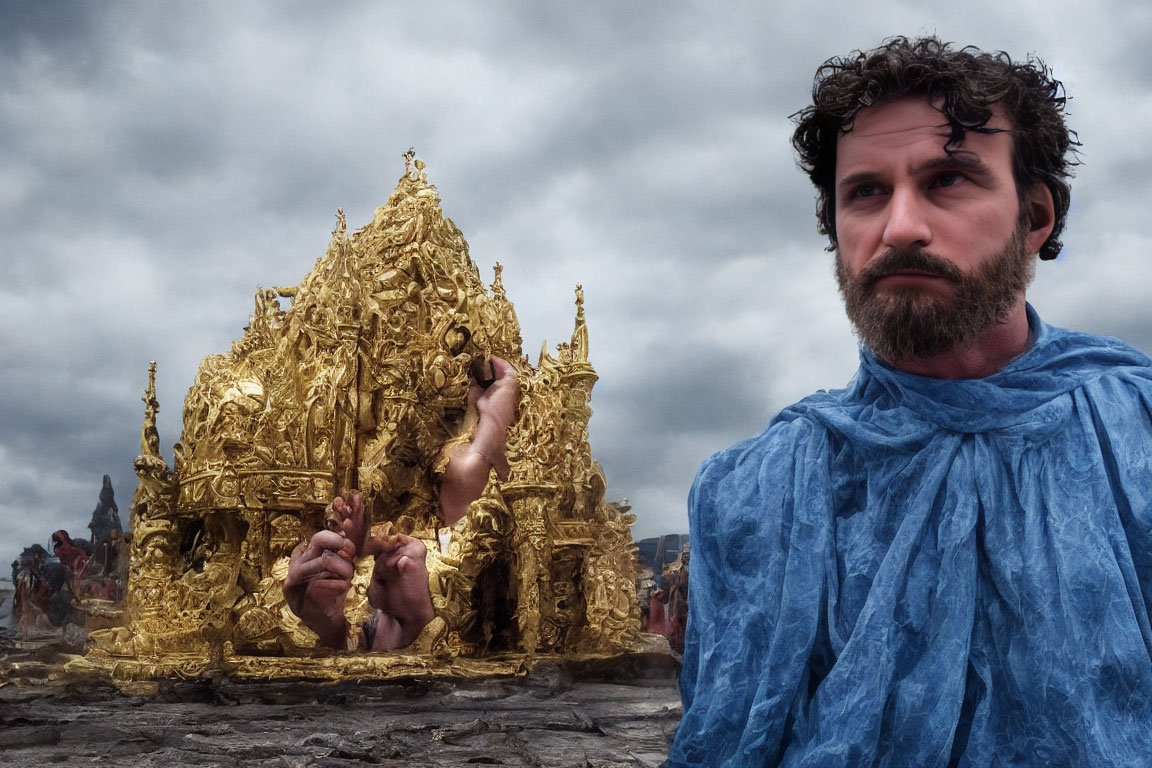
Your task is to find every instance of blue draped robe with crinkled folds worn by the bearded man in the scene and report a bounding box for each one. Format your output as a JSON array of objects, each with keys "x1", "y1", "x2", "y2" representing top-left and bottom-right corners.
[{"x1": 667, "y1": 307, "x2": 1152, "y2": 768}]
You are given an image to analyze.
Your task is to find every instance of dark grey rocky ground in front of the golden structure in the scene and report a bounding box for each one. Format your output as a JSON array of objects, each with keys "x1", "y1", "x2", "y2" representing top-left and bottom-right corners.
[{"x1": 0, "y1": 647, "x2": 680, "y2": 768}]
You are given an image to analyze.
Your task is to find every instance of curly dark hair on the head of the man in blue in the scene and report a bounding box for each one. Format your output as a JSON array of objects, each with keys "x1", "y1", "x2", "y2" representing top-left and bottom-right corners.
[{"x1": 791, "y1": 37, "x2": 1081, "y2": 259}]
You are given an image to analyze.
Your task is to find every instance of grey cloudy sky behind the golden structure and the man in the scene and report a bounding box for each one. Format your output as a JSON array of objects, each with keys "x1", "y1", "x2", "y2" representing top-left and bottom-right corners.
[{"x1": 0, "y1": 0, "x2": 1152, "y2": 571}]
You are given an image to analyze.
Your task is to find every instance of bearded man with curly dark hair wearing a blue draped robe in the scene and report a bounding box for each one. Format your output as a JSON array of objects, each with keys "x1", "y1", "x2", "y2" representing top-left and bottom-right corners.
[{"x1": 668, "y1": 38, "x2": 1152, "y2": 768}]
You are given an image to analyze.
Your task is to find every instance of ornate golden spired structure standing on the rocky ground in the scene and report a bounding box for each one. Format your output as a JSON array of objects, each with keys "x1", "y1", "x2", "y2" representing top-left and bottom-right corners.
[{"x1": 83, "y1": 151, "x2": 639, "y2": 679}]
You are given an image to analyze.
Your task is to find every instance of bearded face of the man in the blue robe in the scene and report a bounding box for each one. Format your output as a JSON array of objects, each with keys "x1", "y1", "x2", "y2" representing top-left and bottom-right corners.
[{"x1": 834, "y1": 98, "x2": 1047, "y2": 362}]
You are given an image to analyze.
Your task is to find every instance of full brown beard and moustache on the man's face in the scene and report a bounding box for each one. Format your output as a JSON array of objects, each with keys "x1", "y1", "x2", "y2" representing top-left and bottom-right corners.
[{"x1": 836, "y1": 223, "x2": 1036, "y2": 363}]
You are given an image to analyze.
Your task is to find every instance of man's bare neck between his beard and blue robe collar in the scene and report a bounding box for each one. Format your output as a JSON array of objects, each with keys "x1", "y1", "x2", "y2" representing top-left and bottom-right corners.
[{"x1": 889, "y1": 296, "x2": 1031, "y2": 379}]
